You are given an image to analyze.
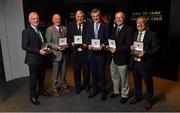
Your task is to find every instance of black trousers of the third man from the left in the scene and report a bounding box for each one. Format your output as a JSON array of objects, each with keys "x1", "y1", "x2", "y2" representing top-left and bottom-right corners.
[{"x1": 72, "y1": 52, "x2": 90, "y2": 88}]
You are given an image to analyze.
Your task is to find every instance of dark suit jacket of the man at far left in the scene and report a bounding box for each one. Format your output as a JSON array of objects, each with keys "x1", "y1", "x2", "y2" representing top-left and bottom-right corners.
[{"x1": 22, "y1": 26, "x2": 46, "y2": 65}]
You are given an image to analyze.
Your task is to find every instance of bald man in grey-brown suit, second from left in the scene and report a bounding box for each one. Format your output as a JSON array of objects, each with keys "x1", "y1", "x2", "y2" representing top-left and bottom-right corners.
[{"x1": 46, "y1": 14, "x2": 70, "y2": 96}]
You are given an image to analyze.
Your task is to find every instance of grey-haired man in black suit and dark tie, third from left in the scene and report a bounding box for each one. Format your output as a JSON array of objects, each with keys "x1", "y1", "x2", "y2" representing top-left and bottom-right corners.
[{"x1": 68, "y1": 10, "x2": 89, "y2": 94}]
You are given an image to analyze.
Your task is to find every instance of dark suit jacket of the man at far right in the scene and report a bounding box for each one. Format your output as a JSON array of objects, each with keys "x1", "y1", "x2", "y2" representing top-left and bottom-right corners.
[{"x1": 131, "y1": 30, "x2": 159, "y2": 65}]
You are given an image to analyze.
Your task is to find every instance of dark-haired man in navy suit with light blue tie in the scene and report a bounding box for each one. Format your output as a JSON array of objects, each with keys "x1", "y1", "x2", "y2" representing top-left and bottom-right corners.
[{"x1": 87, "y1": 9, "x2": 108, "y2": 100}]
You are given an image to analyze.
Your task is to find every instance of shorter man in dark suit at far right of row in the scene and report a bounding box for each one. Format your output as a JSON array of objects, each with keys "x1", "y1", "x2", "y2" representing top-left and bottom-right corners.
[{"x1": 130, "y1": 17, "x2": 159, "y2": 109}]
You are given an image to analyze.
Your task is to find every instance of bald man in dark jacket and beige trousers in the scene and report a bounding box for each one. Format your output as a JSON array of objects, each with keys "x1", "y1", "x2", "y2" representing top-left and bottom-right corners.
[{"x1": 107, "y1": 12, "x2": 133, "y2": 104}]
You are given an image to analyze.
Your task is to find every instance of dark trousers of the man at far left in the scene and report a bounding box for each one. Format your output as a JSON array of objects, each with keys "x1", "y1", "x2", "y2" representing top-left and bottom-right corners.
[{"x1": 29, "y1": 65, "x2": 45, "y2": 97}]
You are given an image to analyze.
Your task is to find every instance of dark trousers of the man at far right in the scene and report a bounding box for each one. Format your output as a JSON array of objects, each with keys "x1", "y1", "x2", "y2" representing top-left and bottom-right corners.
[{"x1": 133, "y1": 62, "x2": 154, "y2": 101}]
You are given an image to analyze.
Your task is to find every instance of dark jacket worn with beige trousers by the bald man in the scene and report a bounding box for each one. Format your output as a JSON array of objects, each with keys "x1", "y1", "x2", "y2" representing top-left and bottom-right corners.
[{"x1": 111, "y1": 25, "x2": 134, "y2": 66}]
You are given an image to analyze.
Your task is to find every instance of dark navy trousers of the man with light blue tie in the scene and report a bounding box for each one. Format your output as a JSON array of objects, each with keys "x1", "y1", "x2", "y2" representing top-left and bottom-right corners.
[{"x1": 89, "y1": 54, "x2": 107, "y2": 95}]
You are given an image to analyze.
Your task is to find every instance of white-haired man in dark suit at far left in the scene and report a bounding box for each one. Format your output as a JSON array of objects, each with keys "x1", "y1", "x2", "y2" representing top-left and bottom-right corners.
[{"x1": 22, "y1": 12, "x2": 49, "y2": 105}]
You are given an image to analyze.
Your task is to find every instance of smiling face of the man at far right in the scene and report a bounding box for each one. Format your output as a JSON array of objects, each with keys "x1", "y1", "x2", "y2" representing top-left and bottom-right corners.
[{"x1": 136, "y1": 18, "x2": 146, "y2": 31}]
